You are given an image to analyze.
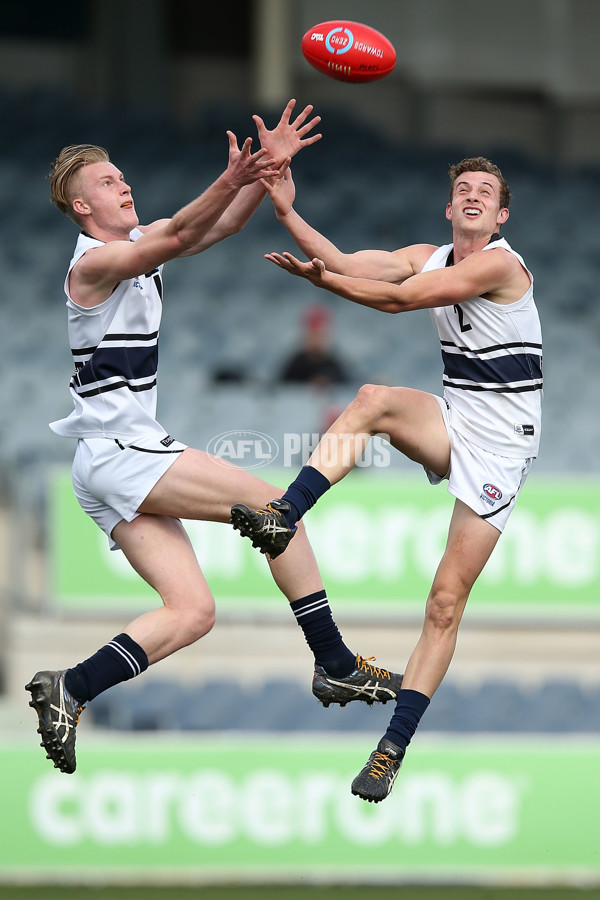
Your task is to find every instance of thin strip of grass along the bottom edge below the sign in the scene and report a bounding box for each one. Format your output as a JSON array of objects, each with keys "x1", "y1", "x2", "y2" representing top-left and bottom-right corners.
[{"x1": 0, "y1": 885, "x2": 600, "y2": 900}]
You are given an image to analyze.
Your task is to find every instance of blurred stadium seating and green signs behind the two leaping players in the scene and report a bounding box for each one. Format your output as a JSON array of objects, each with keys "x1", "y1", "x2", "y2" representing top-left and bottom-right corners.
[{"x1": 0, "y1": 0, "x2": 600, "y2": 896}]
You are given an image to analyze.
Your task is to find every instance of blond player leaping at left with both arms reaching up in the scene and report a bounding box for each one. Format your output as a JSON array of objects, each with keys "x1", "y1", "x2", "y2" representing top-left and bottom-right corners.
[{"x1": 26, "y1": 100, "x2": 401, "y2": 773}]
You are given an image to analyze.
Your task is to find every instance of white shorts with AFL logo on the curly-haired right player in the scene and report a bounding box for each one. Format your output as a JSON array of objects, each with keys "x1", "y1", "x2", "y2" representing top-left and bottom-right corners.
[{"x1": 425, "y1": 395, "x2": 533, "y2": 531}]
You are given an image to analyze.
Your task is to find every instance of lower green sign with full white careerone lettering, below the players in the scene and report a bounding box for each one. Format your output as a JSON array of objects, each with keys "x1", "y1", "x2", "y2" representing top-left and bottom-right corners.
[{"x1": 0, "y1": 732, "x2": 600, "y2": 881}]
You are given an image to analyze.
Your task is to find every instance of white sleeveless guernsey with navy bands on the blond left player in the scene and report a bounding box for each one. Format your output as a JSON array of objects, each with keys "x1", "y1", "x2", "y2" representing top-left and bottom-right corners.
[{"x1": 50, "y1": 228, "x2": 166, "y2": 439}]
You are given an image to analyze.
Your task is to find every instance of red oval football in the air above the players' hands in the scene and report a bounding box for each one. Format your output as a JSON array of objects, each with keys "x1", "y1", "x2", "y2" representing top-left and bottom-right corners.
[{"x1": 302, "y1": 21, "x2": 396, "y2": 82}]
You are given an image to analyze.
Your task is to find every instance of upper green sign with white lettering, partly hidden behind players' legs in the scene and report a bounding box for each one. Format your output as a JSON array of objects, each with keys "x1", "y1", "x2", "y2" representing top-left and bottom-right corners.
[{"x1": 48, "y1": 470, "x2": 600, "y2": 620}]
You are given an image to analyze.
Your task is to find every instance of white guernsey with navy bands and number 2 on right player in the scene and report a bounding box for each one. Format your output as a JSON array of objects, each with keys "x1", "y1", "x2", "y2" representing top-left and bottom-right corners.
[{"x1": 422, "y1": 238, "x2": 543, "y2": 459}]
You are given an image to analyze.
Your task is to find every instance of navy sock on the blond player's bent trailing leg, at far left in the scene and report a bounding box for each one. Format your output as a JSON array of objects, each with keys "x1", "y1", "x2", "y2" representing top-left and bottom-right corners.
[{"x1": 65, "y1": 634, "x2": 148, "y2": 703}]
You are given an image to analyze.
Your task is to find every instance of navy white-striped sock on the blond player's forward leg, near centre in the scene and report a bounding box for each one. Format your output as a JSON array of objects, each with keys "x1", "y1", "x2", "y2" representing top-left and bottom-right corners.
[{"x1": 290, "y1": 591, "x2": 356, "y2": 678}]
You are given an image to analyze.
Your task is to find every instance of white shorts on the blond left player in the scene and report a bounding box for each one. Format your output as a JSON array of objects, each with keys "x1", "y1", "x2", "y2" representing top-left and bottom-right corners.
[{"x1": 71, "y1": 435, "x2": 187, "y2": 550}]
